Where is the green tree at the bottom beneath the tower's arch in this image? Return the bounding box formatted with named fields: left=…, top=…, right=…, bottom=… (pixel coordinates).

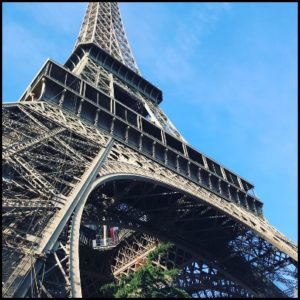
left=101, top=243, right=190, bottom=298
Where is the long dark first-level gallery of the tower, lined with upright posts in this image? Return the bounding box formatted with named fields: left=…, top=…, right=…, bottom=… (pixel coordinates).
left=18, top=58, right=262, bottom=215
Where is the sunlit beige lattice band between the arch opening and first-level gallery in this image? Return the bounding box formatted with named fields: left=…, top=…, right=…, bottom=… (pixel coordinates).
left=101, top=142, right=297, bottom=260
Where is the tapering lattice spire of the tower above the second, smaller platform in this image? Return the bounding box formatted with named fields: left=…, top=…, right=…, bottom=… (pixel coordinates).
left=75, top=2, right=140, bottom=74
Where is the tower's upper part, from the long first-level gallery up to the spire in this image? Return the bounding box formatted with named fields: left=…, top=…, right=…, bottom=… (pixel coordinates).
left=20, top=2, right=263, bottom=216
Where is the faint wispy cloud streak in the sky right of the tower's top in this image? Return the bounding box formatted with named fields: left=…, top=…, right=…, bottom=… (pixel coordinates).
left=155, top=3, right=231, bottom=83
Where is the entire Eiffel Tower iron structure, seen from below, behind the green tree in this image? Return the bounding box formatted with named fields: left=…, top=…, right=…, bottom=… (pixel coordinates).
left=2, top=2, right=298, bottom=298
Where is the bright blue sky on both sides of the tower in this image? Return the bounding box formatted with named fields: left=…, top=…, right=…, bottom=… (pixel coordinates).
left=3, top=3, right=298, bottom=242
